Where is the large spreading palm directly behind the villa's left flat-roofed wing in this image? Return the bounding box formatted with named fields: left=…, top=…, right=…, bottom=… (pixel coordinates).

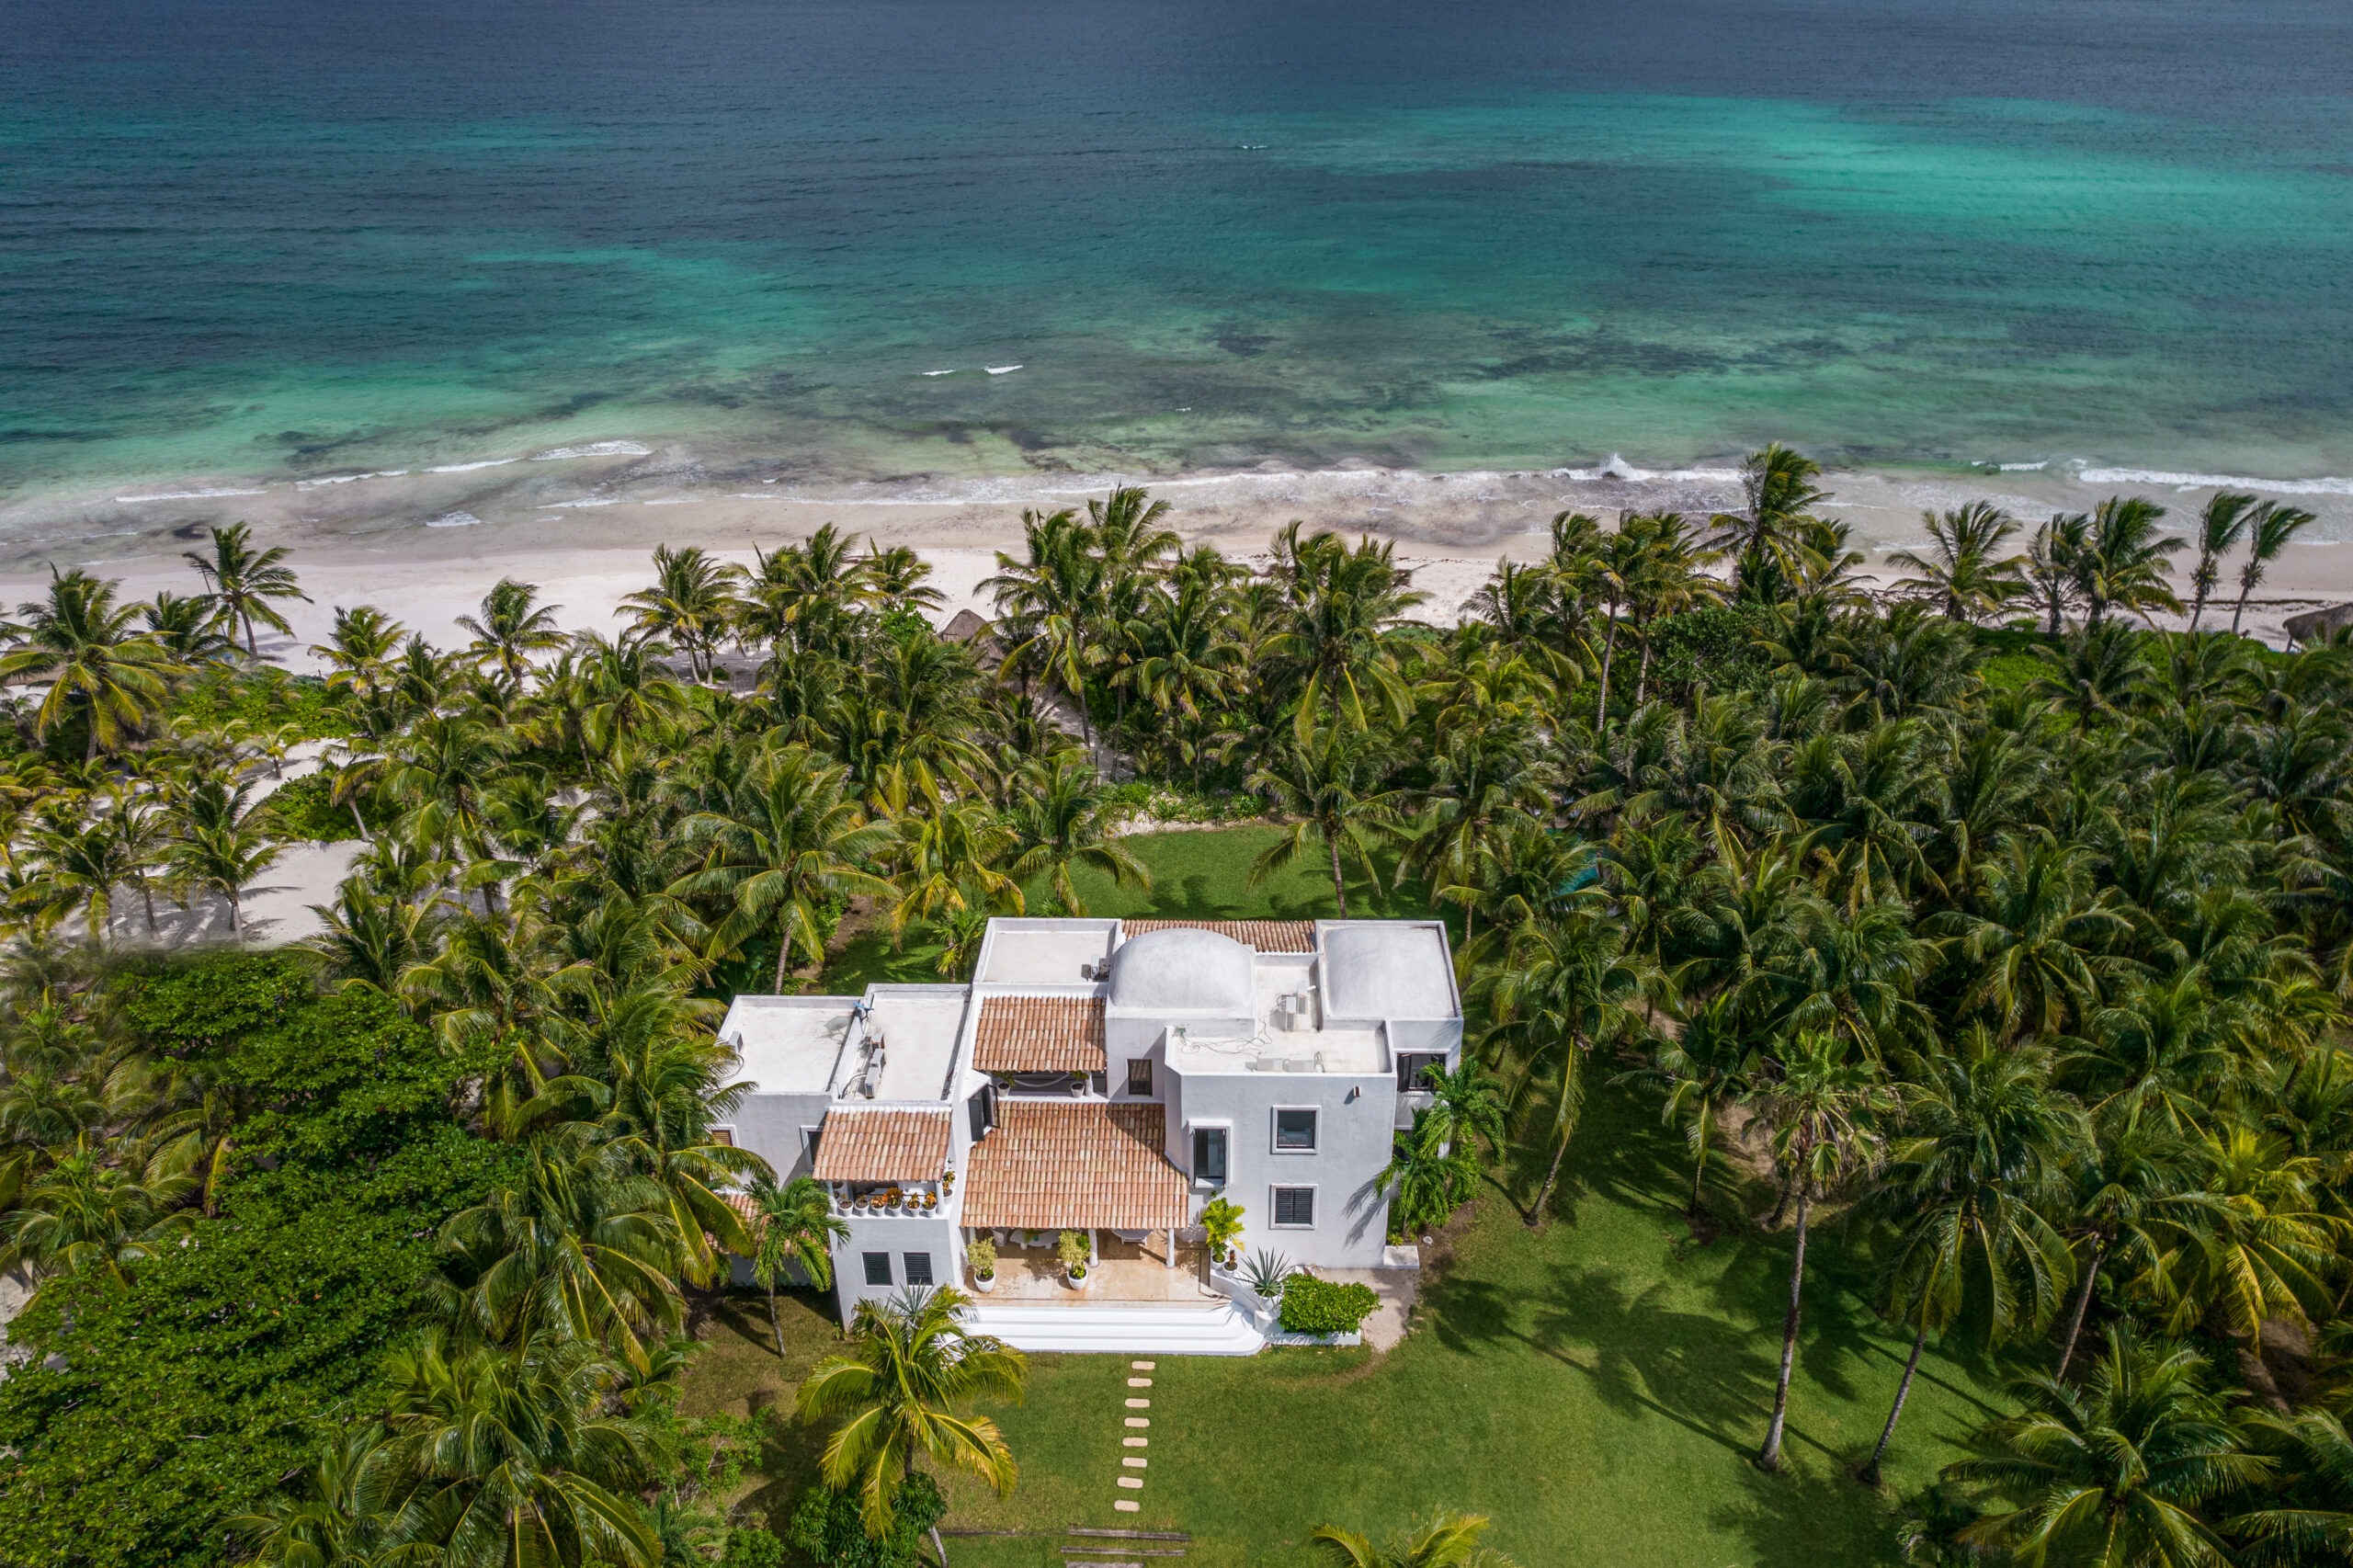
left=673, top=746, right=892, bottom=996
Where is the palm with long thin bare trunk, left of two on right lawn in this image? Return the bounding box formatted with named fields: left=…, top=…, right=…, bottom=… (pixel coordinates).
left=1757, top=1031, right=1894, bottom=1471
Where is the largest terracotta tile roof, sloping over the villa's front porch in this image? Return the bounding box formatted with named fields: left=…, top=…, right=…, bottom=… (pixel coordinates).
left=965, top=1099, right=1193, bottom=1232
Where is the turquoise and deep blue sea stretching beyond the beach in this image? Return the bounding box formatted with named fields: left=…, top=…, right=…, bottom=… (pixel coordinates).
left=0, top=0, right=2353, bottom=499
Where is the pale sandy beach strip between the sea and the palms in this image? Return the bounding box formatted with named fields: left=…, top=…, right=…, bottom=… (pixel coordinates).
left=0, top=443, right=2353, bottom=668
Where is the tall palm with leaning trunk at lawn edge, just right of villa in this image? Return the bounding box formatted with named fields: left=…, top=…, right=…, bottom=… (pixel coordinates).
left=1475, top=900, right=1661, bottom=1224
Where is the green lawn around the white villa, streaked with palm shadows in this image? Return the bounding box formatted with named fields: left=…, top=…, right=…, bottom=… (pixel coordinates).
left=688, top=826, right=2000, bottom=1568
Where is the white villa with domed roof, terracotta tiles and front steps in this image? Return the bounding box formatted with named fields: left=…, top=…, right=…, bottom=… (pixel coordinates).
left=720, top=918, right=1463, bottom=1354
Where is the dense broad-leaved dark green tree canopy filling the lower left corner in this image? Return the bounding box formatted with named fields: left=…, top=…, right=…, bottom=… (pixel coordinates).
left=0, top=1123, right=513, bottom=1568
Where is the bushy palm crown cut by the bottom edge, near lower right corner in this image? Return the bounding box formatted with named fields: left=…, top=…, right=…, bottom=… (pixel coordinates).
left=1944, top=1325, right=2266, bottom=1568
